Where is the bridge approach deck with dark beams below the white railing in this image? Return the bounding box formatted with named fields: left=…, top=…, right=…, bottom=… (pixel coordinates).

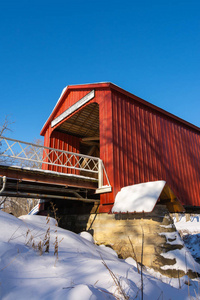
left=0, top=165, right=99, bottom=202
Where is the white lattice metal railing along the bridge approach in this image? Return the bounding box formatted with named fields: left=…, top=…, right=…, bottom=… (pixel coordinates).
left=0, top=136, right=110, bottom=188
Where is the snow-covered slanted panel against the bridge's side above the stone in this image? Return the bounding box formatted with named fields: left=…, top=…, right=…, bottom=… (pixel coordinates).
left=112, top=180, right=166, bottom=213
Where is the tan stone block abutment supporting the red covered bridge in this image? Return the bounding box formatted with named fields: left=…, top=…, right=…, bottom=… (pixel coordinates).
left=57, top=205, right=198, bottom=277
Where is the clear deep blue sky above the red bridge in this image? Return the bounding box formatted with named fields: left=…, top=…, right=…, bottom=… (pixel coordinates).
left=0, top=0, right=200, bottom=142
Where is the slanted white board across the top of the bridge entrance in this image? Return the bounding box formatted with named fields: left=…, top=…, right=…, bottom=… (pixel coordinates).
left=51, top=90, right=95, bottom=127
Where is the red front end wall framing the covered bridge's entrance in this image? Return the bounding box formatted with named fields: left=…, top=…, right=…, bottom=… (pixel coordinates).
left=43, top=89, right=114, bottom=209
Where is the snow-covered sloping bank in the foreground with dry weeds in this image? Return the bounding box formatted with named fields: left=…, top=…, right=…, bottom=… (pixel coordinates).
left=0, top=211, right=200, bottom=300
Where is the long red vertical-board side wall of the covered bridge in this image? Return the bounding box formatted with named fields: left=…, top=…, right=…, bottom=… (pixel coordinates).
left=112, top=91, right=200, bottom=210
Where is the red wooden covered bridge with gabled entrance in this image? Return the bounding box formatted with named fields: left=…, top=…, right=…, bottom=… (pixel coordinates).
left=41, top=83, right=200, bottom=212
